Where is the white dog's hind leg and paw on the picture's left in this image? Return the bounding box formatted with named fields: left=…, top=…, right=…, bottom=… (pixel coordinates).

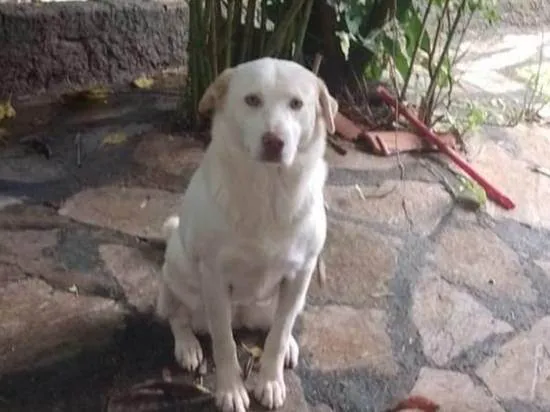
left=157, top=282, right=204, bottom=371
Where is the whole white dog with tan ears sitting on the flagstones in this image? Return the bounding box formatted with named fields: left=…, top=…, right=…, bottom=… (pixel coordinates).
left=157, top=58, right=338, bottom=412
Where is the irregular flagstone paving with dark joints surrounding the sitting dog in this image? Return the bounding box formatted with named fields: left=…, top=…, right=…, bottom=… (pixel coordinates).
left=0, top=84, right=550, bottom=412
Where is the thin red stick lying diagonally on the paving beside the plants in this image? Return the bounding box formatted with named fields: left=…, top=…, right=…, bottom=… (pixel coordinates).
left=376, top=86, right=516, bottom=210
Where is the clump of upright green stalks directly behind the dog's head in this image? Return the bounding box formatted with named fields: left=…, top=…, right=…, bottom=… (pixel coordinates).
left=187, top=0, right=315, bottom=127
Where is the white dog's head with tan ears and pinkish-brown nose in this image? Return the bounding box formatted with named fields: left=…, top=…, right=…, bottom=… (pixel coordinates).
left=199, top=58, right=338, bottom=166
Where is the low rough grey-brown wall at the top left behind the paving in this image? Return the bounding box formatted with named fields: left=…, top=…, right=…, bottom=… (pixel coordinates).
left=0, top=1, right=189, bottom=99
